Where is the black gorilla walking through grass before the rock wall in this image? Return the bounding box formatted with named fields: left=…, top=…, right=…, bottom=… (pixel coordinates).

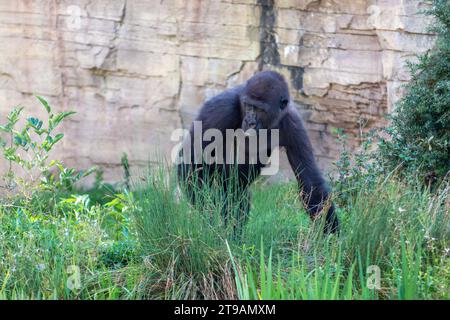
left=178, top=71, right=338, bottom=233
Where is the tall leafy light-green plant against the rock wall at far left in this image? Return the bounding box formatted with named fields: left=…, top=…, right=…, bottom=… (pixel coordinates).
left=0, top=96, right=93, bottom=196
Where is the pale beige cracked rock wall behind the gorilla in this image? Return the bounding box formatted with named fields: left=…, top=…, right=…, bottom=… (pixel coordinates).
left=0, top=0, right=434, bottom=180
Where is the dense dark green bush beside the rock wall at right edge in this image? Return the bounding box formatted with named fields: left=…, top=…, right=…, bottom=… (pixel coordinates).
left=379, top=0, right=450, bottom=184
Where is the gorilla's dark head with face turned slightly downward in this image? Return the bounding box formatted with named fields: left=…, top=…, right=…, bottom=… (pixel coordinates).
left=241, top=71, right=289, bottom=131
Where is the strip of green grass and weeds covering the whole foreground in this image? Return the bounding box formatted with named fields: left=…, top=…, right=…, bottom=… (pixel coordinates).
left=0, top=166, right=450, bottom=299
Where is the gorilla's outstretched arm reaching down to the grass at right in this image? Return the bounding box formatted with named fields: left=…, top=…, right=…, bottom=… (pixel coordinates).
left=280, top=106, right=338, bottom=232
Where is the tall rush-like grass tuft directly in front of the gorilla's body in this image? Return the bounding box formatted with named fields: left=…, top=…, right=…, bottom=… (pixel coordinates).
left=133, top=167, right=243, bottom=299
